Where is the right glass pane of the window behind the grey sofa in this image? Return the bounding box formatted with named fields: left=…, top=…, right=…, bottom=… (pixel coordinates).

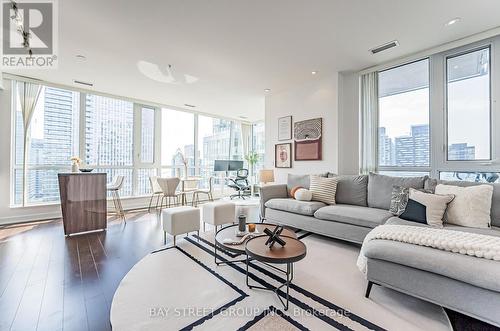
left=446, top=47, right=491, bottom=161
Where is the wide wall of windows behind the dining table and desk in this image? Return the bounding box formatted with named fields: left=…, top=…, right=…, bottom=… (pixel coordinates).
left=11, top=82, right=262, bottom=205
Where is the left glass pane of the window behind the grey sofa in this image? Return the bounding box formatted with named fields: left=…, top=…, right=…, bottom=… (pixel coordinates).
left=378, top=59, right=430, bottom=167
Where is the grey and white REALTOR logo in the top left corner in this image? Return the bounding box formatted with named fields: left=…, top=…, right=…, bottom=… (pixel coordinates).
left=1, top=0, right=57, bottom=69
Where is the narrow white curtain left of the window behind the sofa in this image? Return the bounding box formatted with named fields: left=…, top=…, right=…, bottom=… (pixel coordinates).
left=360, top=72, right=378, bottom=174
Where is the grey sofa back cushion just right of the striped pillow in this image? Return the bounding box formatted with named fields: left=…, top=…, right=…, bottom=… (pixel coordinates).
left=329, top=175, right=368, bottom=207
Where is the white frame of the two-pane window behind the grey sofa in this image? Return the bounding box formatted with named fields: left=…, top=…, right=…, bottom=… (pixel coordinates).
left=375, top=35, right=500, bottom=178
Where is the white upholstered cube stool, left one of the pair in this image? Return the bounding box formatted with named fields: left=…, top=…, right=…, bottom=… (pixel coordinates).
left=161, top=206, right=200, bottom=246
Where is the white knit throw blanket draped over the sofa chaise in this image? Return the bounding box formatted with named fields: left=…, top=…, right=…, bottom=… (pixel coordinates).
left=357, top=224, right=500, bottom=274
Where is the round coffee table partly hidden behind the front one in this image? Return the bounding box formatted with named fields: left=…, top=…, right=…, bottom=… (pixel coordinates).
left=214, top=223, right=297, bottom=265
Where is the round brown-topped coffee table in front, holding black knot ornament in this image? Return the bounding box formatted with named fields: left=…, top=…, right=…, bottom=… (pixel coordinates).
left=245, top=235, right=307, bottom=310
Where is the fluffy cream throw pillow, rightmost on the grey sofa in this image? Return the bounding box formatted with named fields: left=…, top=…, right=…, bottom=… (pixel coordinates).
left=435, top=184, right=493, bottom=228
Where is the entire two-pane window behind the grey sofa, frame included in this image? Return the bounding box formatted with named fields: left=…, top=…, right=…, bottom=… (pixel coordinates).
left=367, top=36, right=500, bottom=182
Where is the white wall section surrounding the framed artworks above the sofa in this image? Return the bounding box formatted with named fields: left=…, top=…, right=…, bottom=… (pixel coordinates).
left=265, top=73, right=340, bottom=183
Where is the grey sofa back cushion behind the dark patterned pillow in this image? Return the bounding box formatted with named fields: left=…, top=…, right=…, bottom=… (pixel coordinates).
left=368, top=172, right=428, bottom=210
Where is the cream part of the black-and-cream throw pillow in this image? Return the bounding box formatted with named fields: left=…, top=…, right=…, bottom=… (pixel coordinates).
left=408, top=188, right=455, bottom=228
